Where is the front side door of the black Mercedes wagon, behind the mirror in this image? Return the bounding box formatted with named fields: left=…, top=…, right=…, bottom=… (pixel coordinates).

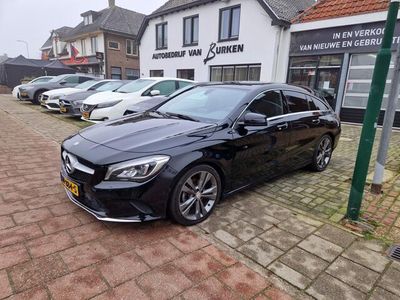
left=231, top=90, right=290, bottom=188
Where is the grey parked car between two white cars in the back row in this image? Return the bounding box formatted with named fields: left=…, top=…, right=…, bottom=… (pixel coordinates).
left=59, top=79, right=132, bottom=117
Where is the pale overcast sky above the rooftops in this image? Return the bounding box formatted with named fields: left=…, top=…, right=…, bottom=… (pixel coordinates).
left=0, top=0, right=166, bottom=58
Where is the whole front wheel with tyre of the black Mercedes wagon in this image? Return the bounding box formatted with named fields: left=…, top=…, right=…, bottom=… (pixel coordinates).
left=168, top=165, right=222, bottom=226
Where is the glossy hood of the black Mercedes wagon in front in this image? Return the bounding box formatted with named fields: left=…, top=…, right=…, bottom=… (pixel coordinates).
left=79, top=113, right=217, bottom=153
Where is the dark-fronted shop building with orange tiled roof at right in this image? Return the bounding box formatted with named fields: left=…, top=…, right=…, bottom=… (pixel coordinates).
left=287, top=0, right=400, bottom=127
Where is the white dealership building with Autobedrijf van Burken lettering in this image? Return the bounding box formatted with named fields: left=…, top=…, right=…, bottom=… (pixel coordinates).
left=138, top=0, right=315, bottom=82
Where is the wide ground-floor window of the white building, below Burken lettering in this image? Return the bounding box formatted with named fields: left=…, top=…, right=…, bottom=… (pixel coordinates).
left=210, top=64, right=261, bottom=81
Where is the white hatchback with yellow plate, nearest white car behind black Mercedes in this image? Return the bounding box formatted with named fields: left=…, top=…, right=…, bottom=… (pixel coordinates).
left=81, top=77, right=194, bottom=123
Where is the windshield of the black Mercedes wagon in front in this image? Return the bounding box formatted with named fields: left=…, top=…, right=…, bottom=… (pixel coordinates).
left=157, top=86, right=247, bottom=123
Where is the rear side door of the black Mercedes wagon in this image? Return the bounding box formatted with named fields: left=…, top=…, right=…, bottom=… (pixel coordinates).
left=283, top=91, right=321, bottom=169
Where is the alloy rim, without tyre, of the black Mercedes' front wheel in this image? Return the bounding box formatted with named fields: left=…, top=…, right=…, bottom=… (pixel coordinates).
left=179, top=171, right=219, bottom=221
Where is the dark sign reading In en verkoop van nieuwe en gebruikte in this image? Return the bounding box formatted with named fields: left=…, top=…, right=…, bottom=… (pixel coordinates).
left=290, top=22, right=400, bottom=56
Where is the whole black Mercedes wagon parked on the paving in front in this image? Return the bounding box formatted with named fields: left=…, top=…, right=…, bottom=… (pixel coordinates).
left=61, top=83, right=341, bottom=225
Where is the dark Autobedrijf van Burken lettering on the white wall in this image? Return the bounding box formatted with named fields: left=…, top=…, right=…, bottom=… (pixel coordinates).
left=153, top=42, right=244, bottom=64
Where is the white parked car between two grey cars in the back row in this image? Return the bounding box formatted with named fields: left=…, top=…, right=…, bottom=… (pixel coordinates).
left=39, top=79, right=112, bottom=111
